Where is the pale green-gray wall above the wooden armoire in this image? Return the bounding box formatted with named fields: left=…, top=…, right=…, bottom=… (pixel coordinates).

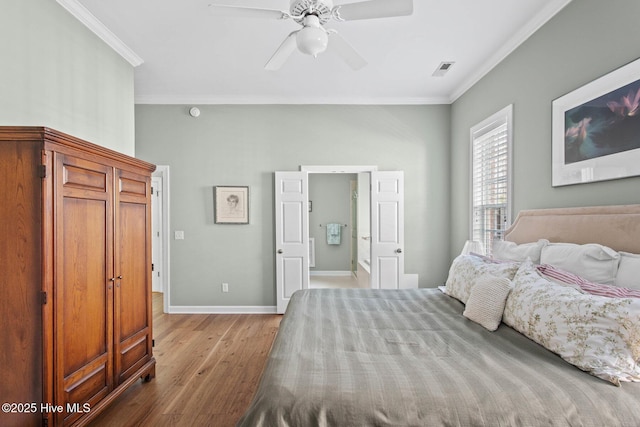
left=0, top=0, right=135, bottom=155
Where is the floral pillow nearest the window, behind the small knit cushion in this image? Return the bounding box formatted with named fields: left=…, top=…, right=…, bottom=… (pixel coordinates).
left=445, top=255, right=520, bottom=304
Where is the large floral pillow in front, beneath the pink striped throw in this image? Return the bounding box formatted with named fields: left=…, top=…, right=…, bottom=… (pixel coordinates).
left=503, top=261, right=640, bottom=386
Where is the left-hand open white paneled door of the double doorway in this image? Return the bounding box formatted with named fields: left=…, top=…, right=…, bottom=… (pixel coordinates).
left=275, top=172, right=309, bottom=313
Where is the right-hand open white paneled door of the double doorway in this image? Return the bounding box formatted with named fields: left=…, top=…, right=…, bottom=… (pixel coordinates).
left=371, top=171, right=404, bottom=289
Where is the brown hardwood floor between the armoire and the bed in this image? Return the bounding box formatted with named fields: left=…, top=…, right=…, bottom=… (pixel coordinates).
left=90, top=293, right=281, bottom=427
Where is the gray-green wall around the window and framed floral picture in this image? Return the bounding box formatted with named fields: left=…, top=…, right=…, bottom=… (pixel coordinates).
left=451, top=0, right=640, bottom=257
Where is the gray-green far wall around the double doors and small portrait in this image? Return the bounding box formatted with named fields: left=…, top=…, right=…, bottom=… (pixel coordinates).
left=136, top=105, right=450, bottom=306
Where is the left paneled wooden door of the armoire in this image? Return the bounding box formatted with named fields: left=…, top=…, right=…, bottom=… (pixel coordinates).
left=54, top=153, right=114, bottom=425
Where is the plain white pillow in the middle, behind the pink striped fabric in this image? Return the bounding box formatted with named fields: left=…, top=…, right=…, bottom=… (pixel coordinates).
left=540, top=243, right=620, bottom=285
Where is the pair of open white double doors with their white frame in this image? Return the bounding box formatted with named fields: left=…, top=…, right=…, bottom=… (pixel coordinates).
left=274, top=166, right=404, bottom=313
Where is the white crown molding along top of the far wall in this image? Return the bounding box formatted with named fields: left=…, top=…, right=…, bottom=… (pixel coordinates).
left=135, top=95, right=450, bottom=105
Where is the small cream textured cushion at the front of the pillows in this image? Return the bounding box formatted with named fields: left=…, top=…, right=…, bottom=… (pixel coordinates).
left=462, top=274, right=511, bottom=331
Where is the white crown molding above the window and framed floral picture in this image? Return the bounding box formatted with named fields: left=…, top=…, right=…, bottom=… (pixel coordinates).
left=448, top=0, right=571, bottom=104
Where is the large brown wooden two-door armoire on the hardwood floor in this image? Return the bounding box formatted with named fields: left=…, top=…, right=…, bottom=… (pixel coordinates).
left=0, top=127, right=155, bottom=427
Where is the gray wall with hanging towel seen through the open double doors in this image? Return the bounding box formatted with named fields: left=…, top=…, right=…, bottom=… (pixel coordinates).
left=309, top=173, right=358, bottom=271
